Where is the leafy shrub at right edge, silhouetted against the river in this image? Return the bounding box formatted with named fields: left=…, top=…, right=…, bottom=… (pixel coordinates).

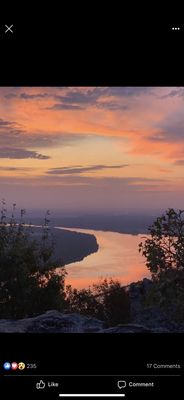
left=139, top=208, right=184, bottom=322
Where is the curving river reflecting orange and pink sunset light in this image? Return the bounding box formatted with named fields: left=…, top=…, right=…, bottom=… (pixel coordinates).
left=54, top=227, right=150, bottom=289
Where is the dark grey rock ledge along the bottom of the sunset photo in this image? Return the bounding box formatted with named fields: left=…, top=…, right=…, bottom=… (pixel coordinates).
left=0, top=310, right=184, bottom=334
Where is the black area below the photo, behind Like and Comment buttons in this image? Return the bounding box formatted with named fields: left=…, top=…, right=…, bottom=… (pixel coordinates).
left=0, top=333, right=184, bottom=399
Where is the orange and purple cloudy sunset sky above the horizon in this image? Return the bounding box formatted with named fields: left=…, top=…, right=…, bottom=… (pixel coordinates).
left=0, top=87, right=184, bottom=214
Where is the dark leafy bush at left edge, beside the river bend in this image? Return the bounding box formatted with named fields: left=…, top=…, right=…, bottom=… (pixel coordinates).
left=0, top=200, right=66, bottom=318
